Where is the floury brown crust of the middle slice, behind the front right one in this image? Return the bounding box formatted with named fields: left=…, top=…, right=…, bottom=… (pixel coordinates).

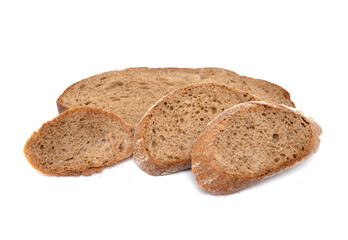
left=133, top=83, right=258, bottom=176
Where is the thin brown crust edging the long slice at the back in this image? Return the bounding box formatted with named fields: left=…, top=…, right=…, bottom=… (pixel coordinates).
left=56, top=67, right=295, bottom=126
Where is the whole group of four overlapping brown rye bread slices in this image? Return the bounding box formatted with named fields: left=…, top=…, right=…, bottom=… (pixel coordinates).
left=24, top=68, right=321, bottom=194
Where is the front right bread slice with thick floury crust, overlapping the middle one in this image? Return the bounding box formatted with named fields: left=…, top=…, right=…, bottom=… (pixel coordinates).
left=192, top=102, right=321, bottom=194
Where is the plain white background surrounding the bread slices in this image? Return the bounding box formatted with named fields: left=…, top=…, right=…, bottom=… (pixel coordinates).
left=0, top=0, right=348, bottom=239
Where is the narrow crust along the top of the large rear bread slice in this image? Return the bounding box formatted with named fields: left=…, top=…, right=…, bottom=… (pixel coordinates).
left=56, top=67, right=295, bottom=129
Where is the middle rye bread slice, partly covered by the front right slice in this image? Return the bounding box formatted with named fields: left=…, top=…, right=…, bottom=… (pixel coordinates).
left=133, top=83, right=258, bottom=175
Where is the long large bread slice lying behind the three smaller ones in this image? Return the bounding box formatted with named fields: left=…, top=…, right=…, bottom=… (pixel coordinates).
left=57, top=68, right=295, bottom=128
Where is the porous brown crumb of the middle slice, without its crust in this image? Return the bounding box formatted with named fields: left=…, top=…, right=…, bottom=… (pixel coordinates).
left=144, top=84, right=255, bottom=163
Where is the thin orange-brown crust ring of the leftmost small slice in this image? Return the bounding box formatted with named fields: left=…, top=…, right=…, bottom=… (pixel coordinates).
left=23, top=106, right=133, bottom=176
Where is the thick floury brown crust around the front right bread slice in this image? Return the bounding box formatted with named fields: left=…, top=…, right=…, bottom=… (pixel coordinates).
left=192, top=102, right=321, bottom=194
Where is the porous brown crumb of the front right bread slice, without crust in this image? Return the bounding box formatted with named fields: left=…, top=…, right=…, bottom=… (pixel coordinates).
left=214, top=105, right=313, bottom=177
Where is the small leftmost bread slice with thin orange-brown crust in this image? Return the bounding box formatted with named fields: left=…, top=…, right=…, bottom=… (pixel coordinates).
left=24, top=107, right=133, bottom=175
